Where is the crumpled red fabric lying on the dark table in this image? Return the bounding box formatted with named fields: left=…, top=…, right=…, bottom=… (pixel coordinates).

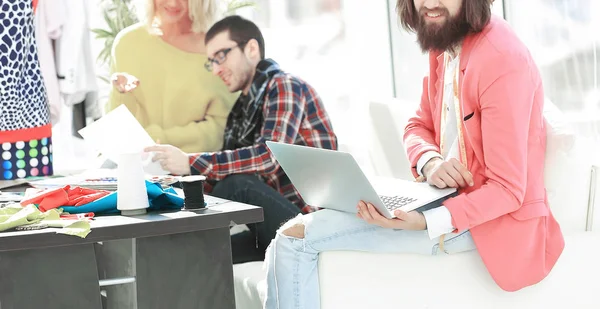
left=21, top=185, right=110, bottom=212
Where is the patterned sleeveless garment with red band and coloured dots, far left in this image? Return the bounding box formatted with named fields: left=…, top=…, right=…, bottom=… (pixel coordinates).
left=0, top=0, right=53, bottom=180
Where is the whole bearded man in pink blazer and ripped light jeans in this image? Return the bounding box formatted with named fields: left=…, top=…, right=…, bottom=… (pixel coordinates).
left=265, top=0, right=564, bottom=309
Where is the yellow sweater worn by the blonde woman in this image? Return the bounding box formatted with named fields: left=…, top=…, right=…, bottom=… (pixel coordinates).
left=108, top=24, right=239, bottom=153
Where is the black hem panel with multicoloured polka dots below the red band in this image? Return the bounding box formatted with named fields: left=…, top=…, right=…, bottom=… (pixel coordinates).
left=0, top=138, right=53, bottom=179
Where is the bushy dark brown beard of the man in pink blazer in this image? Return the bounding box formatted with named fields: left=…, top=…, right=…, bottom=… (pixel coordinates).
left=417, top=7, right=470, bottom=52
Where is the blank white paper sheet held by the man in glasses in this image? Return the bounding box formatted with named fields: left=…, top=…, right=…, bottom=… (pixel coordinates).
left=79, top=105, right=168, bottom=175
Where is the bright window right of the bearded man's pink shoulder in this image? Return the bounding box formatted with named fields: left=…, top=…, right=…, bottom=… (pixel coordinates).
left=504, top=0, right=600, bottom=140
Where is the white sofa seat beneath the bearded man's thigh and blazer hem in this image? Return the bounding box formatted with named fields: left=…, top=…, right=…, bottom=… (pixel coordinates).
left=319, top=232, right=600, bottom=309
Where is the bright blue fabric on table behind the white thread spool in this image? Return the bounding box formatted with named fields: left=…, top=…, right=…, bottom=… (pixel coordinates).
left=60, top=181, right=183, bottom=215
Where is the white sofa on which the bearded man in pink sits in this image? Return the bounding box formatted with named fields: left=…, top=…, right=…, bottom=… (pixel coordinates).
left=234, top=100, right=600, bottom=309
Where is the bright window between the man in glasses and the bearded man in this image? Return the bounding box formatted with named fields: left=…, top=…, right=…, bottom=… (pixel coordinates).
left=238, top=0, right=393, bottom=168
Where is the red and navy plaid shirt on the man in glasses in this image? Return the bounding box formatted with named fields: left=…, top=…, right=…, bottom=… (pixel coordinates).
left=189, top=59, right=337, bottom=213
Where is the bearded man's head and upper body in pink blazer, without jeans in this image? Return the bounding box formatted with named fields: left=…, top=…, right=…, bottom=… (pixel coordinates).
left=398, top=0, right=564, bottom=291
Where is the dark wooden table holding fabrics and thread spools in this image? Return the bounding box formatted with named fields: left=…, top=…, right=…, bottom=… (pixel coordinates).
left=0, top=197, right=263, bottom=309
